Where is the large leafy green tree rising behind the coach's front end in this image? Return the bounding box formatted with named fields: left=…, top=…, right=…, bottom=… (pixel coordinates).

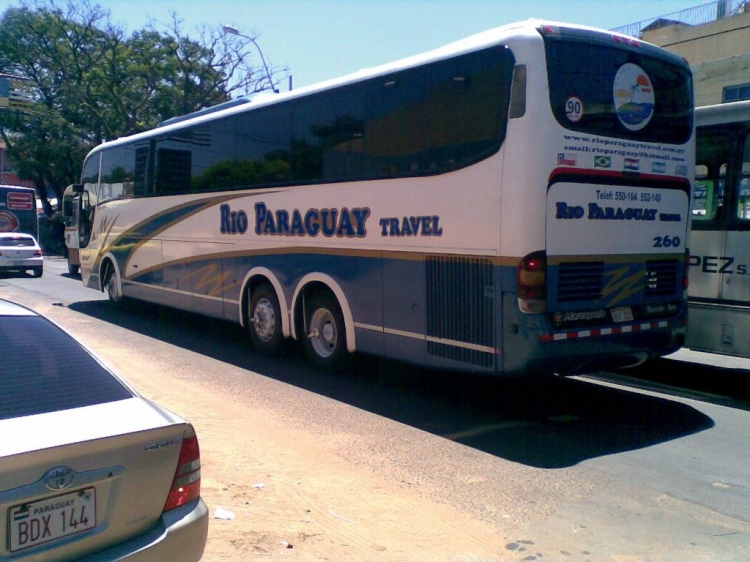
left=0, top=0, right=287, bottom=214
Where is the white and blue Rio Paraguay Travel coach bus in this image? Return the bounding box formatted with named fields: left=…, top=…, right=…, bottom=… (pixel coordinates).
left=67, top=21, right=695, bottom=376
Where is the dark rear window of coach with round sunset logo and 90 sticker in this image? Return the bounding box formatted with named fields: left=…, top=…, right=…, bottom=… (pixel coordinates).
left=544, top=34, right=693, bottom=144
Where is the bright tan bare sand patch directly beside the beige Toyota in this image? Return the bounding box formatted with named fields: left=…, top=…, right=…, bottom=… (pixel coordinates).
left=108, top=348, right=520, bottom=562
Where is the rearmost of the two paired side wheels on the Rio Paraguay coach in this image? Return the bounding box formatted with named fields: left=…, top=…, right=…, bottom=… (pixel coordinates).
left=303, top=292, right=348, bottom=373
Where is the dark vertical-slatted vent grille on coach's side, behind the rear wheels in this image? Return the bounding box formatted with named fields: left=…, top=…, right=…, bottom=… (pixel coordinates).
left=425, top=256, right=495, bottom=367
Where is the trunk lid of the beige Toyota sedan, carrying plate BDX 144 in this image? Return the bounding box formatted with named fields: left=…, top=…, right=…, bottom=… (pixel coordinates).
left=0, top=397, right=191, bottom=560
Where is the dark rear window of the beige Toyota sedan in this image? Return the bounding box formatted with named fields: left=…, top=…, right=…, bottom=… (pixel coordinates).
left=0, top=316, right=133, bottom=419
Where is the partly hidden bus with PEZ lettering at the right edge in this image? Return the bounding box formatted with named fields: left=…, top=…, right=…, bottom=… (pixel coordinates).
left=686, top=101, right=750, bottom=357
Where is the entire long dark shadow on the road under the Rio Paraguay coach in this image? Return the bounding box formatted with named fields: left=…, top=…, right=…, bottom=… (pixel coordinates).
left=69, top=301, right=714, bottom=469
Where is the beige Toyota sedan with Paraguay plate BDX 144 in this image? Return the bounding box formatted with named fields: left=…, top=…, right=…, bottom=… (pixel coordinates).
left=0, top=299, right=208, bottom=562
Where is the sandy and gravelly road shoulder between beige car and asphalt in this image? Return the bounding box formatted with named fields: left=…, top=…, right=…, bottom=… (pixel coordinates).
left=82, top=326, right=748, bottom=562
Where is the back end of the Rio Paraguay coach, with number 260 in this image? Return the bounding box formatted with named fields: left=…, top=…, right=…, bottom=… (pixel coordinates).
left=503, top=26, right=693, bottom=374
